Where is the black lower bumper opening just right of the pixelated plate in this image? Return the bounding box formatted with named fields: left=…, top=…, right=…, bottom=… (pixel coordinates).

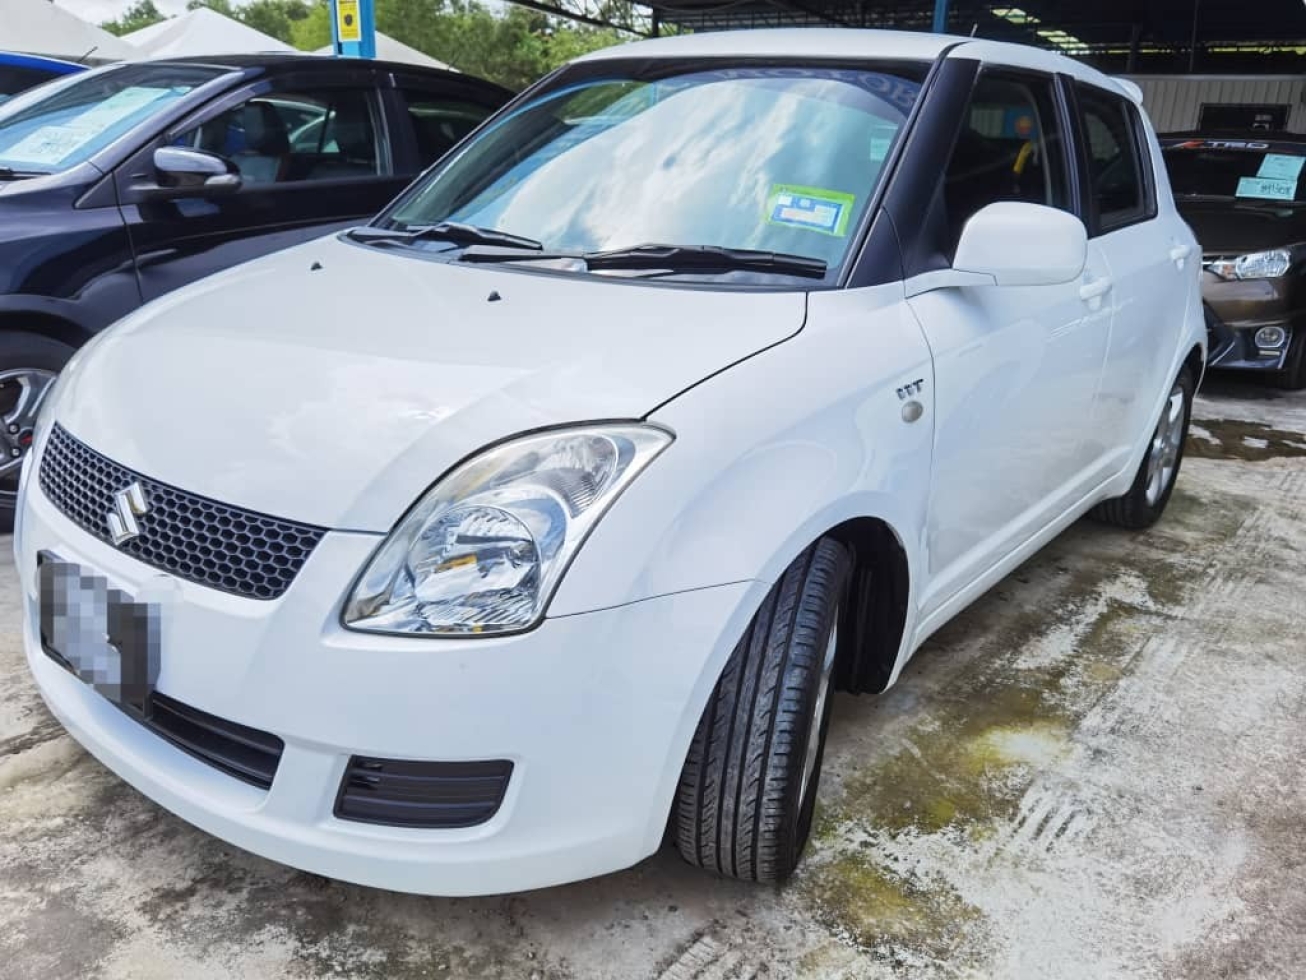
left=145, top=691, right=286, bottom=789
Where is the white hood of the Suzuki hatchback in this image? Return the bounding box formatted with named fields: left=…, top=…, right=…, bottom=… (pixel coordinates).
left=47, top=238, right=806, bottom=532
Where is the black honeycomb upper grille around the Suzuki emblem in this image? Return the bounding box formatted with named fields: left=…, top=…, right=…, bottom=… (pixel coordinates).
left=39, top=425, right=327, bottom=598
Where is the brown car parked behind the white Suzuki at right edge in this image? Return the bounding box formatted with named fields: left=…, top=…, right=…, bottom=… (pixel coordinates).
left=1161, top=132, right=1306, bottom=388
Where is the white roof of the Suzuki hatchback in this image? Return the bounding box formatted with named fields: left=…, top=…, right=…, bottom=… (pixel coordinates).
left=576, top=27, right=1140, bottom=102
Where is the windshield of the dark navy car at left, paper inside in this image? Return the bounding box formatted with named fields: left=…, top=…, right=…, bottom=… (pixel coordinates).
left=0, top=64, right=222, bottom=174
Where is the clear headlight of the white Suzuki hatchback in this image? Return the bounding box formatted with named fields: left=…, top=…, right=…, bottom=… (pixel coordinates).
left=343, top=425, right=671, bottom=636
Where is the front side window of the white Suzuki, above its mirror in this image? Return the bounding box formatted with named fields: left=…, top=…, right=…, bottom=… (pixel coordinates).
left=943, top=73, right=1071, bottom=255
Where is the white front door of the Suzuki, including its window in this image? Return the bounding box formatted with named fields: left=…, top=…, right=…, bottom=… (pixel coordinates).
left=910, top=72, right=1111, bottom=617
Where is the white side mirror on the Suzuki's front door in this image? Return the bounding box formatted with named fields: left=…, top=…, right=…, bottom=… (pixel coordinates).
left=952, top=201, right=1088, bottom=286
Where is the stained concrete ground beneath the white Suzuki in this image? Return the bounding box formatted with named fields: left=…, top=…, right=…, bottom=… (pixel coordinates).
left=0, top=385, right=1306, bottom=980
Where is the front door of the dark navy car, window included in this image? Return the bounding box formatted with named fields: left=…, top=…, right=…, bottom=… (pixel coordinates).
left=116, top=68, right=407, bottom=301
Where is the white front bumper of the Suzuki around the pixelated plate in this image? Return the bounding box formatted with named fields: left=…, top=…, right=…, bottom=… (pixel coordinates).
left=16, top=475, right=765, bottom=895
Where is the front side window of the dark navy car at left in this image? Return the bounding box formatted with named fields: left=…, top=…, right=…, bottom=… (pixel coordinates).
left=174, top=89, right=381, bottom=186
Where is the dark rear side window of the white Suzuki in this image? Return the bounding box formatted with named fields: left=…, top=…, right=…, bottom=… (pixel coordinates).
left=1076, top=85, right=1156, bottom=234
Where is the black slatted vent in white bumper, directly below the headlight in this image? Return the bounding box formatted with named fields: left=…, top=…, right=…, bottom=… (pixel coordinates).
left=336, top=755, right=512, bottom=828
